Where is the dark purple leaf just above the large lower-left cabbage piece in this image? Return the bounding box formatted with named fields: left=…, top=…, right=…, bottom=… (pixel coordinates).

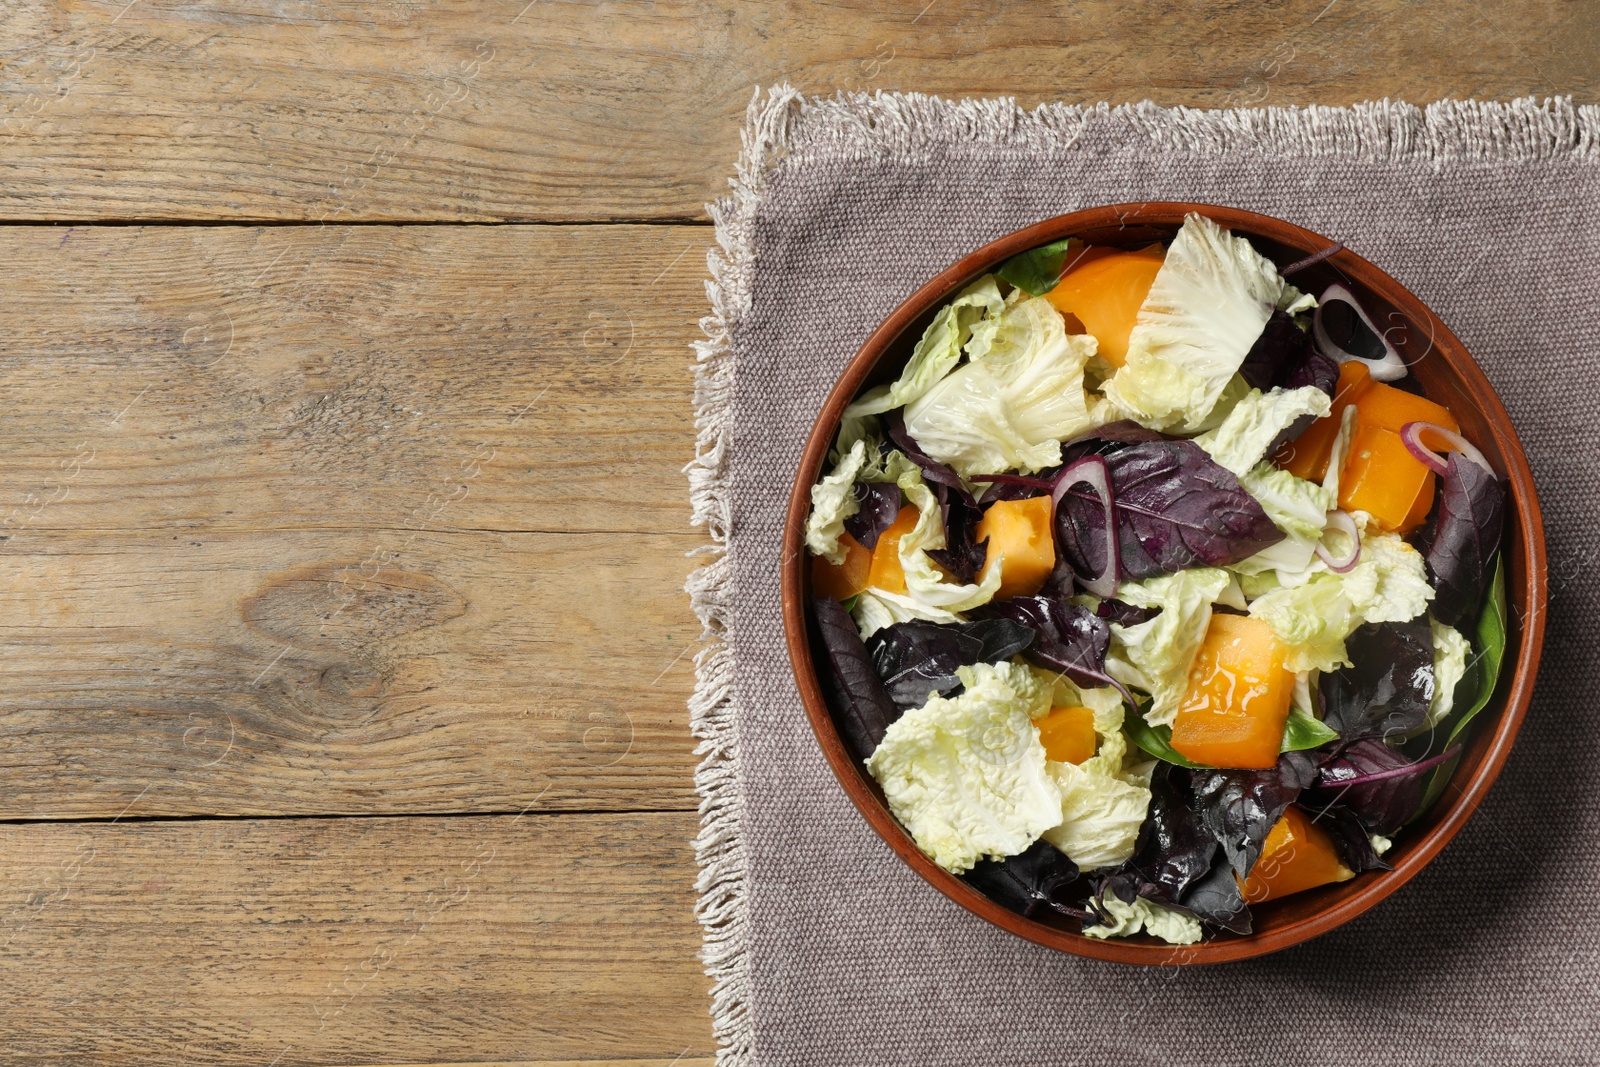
left=867, top=619, right=1034, bottom=707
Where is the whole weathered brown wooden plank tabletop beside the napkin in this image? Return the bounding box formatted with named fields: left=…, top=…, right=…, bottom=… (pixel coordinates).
left=0, top=0, right=1600, bottom=1067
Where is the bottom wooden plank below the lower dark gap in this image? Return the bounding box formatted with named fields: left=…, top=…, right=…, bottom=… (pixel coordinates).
left=0, top=813, right=712, bottom=1067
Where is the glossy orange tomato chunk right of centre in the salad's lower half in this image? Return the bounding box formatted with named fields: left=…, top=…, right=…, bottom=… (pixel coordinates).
left=1173, top=613, right=1294, bottom=768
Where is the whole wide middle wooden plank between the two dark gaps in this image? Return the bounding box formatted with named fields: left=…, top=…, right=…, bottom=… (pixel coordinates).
left=0, top=226, right=707, bottom=819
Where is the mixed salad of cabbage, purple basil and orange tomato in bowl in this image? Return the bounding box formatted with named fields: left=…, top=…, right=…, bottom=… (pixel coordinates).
left=794, top=210, right=1538, bottom=953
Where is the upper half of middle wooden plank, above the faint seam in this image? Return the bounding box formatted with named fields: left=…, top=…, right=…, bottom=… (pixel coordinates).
left=0, top=226, right=710, bottom=541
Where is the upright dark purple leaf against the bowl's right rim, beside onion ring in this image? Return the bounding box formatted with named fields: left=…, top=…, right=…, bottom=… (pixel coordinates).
left=1416, top=453, right=1506, bottom=627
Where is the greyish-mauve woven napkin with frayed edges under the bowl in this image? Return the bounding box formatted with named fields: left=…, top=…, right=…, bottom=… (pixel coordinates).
left=690, top=88, right=1600, bottom=1067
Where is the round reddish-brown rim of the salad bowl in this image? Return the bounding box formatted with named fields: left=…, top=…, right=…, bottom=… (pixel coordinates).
left=781, top=202, right=1549, bottom=966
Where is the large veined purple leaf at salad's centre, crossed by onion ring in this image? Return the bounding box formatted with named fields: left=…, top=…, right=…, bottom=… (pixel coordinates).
left=1056, top=440, right=1283, bottom=579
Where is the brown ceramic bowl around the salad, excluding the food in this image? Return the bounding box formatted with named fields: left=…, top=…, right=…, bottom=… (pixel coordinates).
left=782, top=203, right=1546, bottom=965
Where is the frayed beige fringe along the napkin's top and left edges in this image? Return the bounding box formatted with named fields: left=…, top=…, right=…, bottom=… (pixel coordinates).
left=685, top=85, right=1600, bottom=1067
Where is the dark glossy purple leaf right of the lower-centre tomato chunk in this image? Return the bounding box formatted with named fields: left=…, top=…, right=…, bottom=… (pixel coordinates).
left=1317, top=619, right=1434, bottom=741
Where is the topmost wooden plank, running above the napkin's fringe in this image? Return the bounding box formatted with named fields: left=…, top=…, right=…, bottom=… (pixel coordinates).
left=0, top=0, right=1600, bottom=222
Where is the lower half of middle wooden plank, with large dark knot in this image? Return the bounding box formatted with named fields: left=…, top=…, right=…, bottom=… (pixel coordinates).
left=0, top=531, right=699, bottom=819
